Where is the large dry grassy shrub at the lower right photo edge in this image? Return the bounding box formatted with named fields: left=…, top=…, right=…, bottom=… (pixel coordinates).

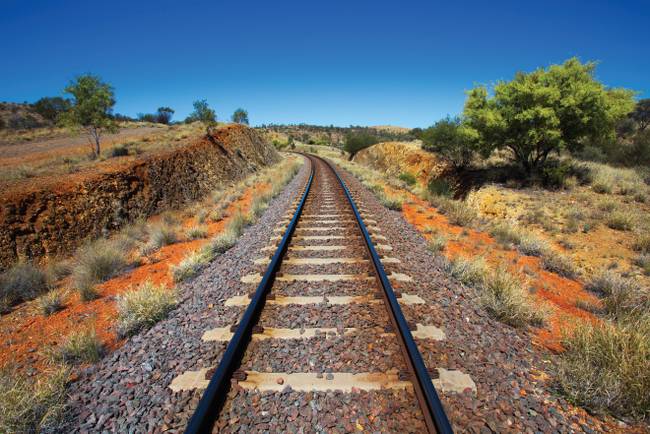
left=556, top=316, right=650, bottom=417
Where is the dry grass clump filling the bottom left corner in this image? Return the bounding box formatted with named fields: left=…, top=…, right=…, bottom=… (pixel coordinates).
left=0, top=368, right=69, bottom=433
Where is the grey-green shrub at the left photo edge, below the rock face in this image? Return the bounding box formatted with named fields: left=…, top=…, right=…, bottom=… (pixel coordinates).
left=0, top=263, right=48, bottom=312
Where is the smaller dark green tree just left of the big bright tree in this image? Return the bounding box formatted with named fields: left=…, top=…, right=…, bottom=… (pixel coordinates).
left=417, top=116, right=479, bottom=170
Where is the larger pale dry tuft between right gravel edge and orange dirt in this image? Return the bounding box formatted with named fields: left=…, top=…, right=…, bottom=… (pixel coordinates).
left=480, top=268, right=547, bottom=327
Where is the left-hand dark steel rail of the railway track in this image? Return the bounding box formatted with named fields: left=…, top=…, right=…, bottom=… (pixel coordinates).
left=185, top=159, right=315, bottom=434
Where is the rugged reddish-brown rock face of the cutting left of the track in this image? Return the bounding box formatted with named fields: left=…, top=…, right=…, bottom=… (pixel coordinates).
left=0, top=125, right=279, bottom=269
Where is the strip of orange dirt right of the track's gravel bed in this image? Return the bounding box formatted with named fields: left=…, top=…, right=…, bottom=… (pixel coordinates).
left=402, top=193, right=600, bottom=352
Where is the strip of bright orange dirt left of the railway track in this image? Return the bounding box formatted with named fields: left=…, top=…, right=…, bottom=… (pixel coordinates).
left=0, top=184, right=270, bottom=371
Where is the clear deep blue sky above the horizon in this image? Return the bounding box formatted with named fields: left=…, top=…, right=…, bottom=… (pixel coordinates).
left=0, top=0, right=650, bottom=127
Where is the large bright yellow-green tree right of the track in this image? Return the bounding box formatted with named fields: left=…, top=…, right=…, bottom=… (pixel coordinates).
left=463, top=58, right=634, bottom=174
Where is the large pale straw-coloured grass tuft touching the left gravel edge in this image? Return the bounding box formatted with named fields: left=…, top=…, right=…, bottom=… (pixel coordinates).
left=117, top=281, right=177, bottom=336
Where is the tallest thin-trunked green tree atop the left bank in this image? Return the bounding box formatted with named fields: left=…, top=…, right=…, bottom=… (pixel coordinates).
left=61, top=74, right=117, bottom=158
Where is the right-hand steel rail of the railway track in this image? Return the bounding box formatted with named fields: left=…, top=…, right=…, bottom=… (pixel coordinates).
left=316, top=157, right=453, bottom=434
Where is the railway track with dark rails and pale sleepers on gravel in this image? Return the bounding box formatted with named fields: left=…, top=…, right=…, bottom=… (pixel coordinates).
left=180, top=155, right=452, bottom=433
